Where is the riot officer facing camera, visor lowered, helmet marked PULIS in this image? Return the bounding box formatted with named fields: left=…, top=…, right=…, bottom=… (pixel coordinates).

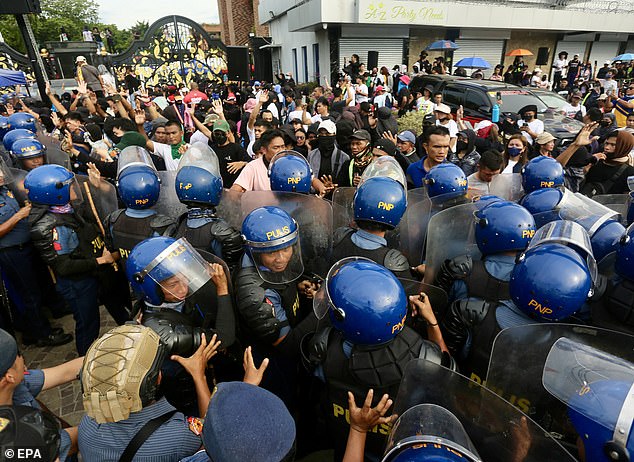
left=235, top=206, right=317, bottom=408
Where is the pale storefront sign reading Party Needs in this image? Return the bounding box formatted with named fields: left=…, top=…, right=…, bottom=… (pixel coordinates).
left=357, top=0, right=447, bottom=25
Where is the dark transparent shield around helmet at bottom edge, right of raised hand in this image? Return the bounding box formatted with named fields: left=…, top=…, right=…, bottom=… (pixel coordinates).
left=384, top=359, right=575, bottom=462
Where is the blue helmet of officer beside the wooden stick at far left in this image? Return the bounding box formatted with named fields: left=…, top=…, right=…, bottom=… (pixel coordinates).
left=24, top=165, right=76, bottom=205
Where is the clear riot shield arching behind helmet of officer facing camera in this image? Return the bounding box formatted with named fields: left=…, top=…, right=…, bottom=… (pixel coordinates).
left=241, top=191, right=333, bottom=276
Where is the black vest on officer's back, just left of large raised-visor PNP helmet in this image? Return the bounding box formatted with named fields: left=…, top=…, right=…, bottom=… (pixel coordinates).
left=461, top=260, right=511, bottom=379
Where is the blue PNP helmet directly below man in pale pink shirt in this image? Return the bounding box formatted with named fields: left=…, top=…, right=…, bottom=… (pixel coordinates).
left=269, top=151, right=313, bottom=194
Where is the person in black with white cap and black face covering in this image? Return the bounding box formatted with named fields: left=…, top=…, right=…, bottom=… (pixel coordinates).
left=308, top=120, right=348, bottom=195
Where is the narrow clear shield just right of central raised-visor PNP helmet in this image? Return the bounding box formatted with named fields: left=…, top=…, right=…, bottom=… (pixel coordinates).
left=398, top=189, right=432, bottom=266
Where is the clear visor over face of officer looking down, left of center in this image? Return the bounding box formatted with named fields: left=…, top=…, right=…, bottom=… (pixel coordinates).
left=137, top=238, right=213, bottom=302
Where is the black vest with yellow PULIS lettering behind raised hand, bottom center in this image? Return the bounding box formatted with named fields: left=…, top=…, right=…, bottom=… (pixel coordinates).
left=322, top=326, right=424, bottom=460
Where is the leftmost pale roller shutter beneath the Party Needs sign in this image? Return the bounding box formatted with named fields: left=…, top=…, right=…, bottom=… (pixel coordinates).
left=339, top=37, right=403, bottom=70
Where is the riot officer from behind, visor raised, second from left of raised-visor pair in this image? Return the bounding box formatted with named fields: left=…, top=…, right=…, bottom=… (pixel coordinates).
left=175, top=143, right=243, bottom=270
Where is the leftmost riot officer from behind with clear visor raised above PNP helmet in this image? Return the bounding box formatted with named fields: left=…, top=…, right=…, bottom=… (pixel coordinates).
left=105, top=146, right=176, bottom=263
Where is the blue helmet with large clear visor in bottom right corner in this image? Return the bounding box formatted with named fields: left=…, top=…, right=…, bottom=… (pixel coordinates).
left=542, top=337, right=634, bottom=462
